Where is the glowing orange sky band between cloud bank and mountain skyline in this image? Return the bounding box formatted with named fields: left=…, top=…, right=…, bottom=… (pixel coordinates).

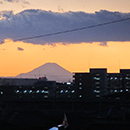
left=0, top=41, right=130, bottom=76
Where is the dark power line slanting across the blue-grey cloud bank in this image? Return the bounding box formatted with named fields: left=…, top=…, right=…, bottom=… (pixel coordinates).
left=0, top=17, right=130, bottom=43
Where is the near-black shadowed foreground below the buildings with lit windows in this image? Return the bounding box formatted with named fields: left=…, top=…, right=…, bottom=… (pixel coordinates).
left=0, top=101, right=130, bottom=130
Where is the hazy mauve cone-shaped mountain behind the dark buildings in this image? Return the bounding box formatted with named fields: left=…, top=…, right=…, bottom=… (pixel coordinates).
left=16, top=63, right=72, bottom=82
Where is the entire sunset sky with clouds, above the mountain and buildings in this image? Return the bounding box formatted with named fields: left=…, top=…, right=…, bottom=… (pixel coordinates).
left=0, top=0, right=130, bottom=77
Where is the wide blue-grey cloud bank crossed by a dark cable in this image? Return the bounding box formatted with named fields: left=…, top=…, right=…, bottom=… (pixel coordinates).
left=0, top=9, right=130, bottom=45
